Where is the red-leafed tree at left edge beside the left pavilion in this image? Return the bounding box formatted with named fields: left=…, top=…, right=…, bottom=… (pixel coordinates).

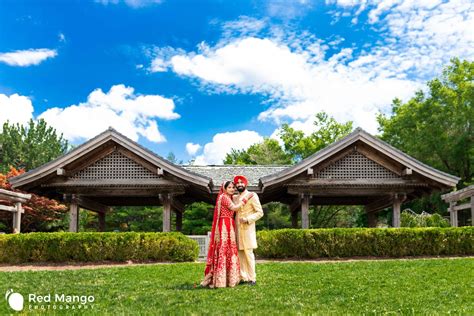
left=0, top=167, right=67, bottom=232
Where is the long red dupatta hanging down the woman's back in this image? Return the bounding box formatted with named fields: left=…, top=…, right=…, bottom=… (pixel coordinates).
left=201, top=184, right=225, bottom=286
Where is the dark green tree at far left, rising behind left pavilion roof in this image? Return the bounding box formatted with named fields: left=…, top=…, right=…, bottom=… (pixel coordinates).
left=0, top=119, right=68, bottom=173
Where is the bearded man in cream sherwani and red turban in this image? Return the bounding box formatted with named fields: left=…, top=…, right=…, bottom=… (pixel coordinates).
left=234, top=175, right=263, bottom=285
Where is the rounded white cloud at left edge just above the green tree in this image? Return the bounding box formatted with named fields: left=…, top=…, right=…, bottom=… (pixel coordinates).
left=0, top=94, right=33, bottom=131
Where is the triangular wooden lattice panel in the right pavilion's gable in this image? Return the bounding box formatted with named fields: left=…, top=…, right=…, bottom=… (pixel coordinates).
left=316, top=152, right=398, bottom=179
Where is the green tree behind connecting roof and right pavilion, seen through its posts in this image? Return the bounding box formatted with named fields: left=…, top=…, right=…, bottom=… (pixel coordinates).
left=224, top=112, right=363, bottom=229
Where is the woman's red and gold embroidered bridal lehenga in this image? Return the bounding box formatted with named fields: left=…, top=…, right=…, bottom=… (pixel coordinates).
left=201, top=187, right=240, bottom=288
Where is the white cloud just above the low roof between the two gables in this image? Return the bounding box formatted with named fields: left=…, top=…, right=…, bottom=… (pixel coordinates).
left=194, top=130, right=263, bottom=165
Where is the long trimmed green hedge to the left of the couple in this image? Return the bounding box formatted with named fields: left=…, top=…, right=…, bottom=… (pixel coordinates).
left=0, top=232, right=199, bottom=263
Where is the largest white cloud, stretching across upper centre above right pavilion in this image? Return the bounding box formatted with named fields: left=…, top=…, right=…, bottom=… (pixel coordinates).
left=163, top=37, right=420, bottom=132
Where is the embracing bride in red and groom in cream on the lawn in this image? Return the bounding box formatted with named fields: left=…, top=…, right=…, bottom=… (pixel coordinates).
left=201, top=176, right=263, bottom=288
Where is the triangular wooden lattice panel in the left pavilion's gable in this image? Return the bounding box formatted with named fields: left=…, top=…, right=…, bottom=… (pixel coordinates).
left=73, top=151, right=159, bottom=180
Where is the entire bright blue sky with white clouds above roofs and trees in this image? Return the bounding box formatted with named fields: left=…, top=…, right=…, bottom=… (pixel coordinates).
left=0, top=0, right=474, bottom=164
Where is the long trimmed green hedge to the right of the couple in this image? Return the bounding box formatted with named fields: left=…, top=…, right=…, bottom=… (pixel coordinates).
left=256, top=227, right=474, bottom=259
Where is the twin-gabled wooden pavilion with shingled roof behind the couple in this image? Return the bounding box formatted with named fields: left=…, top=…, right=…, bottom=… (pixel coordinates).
left=10, top=128, right=459, bottom=232
